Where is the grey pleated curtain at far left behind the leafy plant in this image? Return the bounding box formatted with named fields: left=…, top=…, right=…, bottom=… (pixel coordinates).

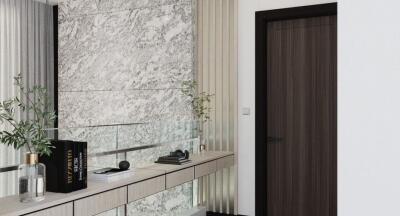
left=0, top=0, right=57, bottom=197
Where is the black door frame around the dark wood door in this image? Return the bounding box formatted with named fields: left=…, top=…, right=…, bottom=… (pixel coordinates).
left=255, top=3, right=337, bottom=216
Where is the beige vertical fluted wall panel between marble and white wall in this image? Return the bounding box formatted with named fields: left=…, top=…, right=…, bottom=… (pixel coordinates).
left=197, top=0, right=237, bottom=213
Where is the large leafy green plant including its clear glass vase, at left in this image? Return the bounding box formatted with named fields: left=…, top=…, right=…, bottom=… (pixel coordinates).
left=0, top=75, right=56, bottom=202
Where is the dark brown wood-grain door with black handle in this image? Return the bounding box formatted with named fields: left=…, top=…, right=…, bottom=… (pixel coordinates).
left=266, top=16, right=337, bottom=216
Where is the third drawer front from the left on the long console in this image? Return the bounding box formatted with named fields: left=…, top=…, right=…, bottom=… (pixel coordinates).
left=128, top=175, right=165, bottom=202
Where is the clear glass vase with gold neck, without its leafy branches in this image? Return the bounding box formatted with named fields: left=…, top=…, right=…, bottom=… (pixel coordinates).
left=18, top=153, right=46, bottom=202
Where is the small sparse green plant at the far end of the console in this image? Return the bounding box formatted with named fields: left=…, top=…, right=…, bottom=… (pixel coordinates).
left=182, top=80, right=214, bottom=152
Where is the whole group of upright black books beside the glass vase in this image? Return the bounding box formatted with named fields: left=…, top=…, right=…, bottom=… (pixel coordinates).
left=39, top=140, right=87, bottom=193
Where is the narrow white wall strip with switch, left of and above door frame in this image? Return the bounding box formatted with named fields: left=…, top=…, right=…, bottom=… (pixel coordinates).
left=238, top=0, right=336, bottom=215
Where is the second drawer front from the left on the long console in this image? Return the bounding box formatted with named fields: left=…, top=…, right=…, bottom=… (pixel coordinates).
left=74, top=187, right=127, bottom=216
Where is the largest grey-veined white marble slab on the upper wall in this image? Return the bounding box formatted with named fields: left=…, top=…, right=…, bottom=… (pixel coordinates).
left=59, top=5, right=194, bottom=91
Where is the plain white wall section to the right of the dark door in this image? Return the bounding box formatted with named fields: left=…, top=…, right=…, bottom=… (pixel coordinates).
left=338, top=0, right=400, bottom=216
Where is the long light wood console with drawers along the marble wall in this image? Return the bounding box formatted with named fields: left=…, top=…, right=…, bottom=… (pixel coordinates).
left=0, top=151, right=234, bottom=216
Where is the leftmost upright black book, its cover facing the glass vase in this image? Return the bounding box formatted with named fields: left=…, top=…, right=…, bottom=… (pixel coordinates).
left=39, top=140, right=74, bottom=193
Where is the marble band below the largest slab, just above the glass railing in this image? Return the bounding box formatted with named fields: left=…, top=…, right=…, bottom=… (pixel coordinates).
left=59, top=89, right=191, bottom=128
